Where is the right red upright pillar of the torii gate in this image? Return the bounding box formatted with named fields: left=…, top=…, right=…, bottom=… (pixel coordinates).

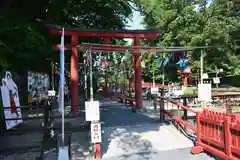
left=134, top=37, right=142, bottom=109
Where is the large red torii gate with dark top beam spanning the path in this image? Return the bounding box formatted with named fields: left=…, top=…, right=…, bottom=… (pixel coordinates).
left=47, top=25, right=201, bottom=112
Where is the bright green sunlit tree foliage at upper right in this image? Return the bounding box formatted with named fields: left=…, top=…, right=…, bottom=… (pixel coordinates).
left=135, top=0, right=240, bottom=82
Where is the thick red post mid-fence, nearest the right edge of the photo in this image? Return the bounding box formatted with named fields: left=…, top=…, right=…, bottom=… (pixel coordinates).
left=223, top=116, right=232, bottom=158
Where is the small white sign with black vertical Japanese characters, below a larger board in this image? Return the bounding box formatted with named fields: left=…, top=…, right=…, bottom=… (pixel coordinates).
left=91, top=122, right=102, bottom=143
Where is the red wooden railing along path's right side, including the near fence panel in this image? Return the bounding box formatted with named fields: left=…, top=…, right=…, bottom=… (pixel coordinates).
left=119, top=95, right=240, bottom=160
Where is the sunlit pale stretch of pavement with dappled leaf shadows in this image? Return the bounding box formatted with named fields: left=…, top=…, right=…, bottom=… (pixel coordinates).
left=103, top=124, right=193, bottom=159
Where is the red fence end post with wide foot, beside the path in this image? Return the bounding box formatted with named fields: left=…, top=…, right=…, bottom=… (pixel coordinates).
left=191, top=112, right=203, bottom=154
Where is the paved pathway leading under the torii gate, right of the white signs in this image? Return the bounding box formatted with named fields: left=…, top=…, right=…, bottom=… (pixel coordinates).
left=101, top=101, right=212, bottom=160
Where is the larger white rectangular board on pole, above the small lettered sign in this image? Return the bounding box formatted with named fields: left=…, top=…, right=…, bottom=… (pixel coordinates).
left=85, top=101, right=100, bottom=121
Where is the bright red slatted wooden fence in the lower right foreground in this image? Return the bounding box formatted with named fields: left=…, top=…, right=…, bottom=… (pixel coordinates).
left=191, top=109, right=240, bottom=160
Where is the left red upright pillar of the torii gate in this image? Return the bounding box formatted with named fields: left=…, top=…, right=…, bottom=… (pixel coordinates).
left=71, top=36, right=78, bottom=112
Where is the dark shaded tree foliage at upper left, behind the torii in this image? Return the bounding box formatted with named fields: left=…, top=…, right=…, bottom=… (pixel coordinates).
left=0, top=0, right=132, bottom=71
